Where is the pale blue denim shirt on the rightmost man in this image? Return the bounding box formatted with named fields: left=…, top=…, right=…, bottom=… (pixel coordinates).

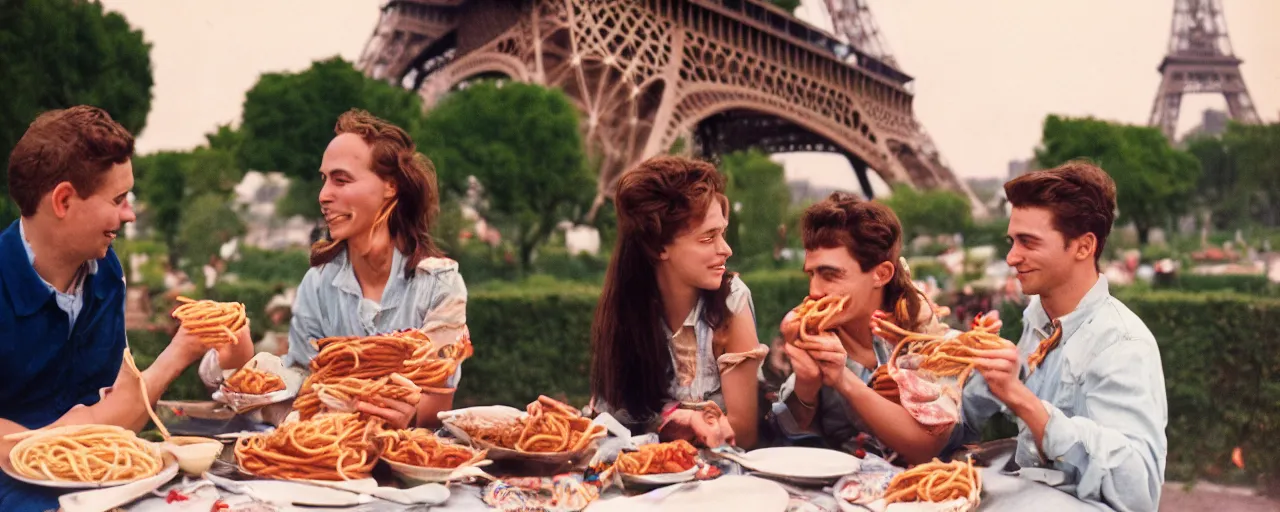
left=948, top=275, right=1169, bottom=511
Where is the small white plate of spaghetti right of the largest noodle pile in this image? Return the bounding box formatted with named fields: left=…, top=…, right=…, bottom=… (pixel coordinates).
left=378, top=429, right=492, bottom=481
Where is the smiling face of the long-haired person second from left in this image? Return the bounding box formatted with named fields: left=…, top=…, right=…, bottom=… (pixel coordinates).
left=320, top=133, right=396, bottom=241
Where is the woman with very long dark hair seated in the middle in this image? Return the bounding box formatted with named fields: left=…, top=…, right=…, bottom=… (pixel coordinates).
left=591, top=156, right=768, bottom=447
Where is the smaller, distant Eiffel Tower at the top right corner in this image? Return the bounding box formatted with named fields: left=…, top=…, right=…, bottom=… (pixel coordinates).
left=1148, top=0, right=1260, bottom=141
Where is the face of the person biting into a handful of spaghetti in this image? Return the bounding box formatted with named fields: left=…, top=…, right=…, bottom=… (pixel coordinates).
left=804, top=247, right=893, bottom=325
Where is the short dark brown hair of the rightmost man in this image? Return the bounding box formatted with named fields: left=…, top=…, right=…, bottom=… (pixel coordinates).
left=1005, top=161, right=1116, bottom=266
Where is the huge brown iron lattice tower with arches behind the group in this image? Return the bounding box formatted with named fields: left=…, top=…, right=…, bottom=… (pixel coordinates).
left=357, top=0, right=984, bottom=215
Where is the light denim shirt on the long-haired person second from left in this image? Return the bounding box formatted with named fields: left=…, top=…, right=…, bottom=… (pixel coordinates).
left=284, top=250, right=467, bottom=387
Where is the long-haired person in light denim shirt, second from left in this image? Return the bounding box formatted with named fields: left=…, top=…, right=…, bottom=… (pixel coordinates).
left=285, top=110, right=467, bottom=428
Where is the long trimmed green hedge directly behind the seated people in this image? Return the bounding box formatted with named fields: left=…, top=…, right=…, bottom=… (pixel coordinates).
left=129, top=271, right=1280, bottom=488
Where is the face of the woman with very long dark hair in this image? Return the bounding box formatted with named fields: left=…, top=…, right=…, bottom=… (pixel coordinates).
left=658, top=202, right=733, bottom=291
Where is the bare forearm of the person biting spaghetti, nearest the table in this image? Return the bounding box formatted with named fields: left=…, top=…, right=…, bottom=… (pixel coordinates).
left=837, top=372, right=951, bottom=463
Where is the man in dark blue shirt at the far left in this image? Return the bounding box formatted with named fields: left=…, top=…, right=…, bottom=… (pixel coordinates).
left=0, top=106, right=242, bottom=512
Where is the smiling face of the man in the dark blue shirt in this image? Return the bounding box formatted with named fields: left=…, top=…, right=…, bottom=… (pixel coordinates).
left=51, top=160, right=137, bottom=261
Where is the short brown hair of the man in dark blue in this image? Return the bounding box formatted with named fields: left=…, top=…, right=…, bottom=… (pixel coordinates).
left=9, top=105, right=133, bottom=216
